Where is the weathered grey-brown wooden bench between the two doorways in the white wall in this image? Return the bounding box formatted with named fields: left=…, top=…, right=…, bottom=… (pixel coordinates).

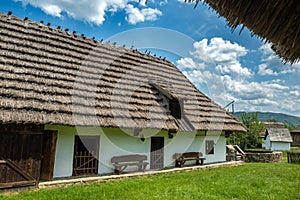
left=111, top=154, right=149, bottom=174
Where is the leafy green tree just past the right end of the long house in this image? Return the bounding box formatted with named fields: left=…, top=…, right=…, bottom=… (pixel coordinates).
left=227, top=113, right=265, bottom=150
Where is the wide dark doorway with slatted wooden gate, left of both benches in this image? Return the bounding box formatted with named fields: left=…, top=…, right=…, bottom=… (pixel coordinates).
left=73, top=135, right=99, bottom=176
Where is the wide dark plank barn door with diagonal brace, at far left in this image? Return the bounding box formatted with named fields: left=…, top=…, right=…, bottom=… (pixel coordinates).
left=0, top=132, right=43, bottom=186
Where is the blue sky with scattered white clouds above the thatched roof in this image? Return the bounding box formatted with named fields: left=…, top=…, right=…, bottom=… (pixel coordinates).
left=0, top=0, right=300, bottom=117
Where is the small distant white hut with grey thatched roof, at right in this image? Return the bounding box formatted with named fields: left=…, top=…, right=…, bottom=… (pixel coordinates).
left=264, top=122, right=293, bottom=151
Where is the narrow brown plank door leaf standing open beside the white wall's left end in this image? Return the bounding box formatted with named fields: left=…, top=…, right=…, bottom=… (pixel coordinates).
left=40, top=131, right=57, bottom=181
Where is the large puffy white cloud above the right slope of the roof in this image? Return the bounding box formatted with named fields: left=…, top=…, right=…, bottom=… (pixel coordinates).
left=191, top=38, right=252, bottom=76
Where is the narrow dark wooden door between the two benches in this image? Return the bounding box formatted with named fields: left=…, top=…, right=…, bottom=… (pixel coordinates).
left=150, top=137, right=164, bottom=169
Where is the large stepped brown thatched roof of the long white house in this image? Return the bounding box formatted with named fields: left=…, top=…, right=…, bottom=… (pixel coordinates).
left=0, top=14, right=246, bottom=131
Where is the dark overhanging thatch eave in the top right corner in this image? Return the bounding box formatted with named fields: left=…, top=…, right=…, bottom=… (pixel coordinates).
left=186, top=0, right=300, bottom=63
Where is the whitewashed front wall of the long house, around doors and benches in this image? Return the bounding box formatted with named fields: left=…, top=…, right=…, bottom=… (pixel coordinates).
left=45, top=125, right=226, bottom=177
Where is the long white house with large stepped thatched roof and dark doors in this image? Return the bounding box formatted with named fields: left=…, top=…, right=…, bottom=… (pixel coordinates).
left=0, top=14, right=246, bottom=188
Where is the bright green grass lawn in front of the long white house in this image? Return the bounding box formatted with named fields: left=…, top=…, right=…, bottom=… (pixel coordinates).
left=0, top=162, right=300, bottom=200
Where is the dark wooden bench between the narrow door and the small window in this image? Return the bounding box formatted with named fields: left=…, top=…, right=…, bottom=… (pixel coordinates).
left=174, top=152, right=205, bottom=167
